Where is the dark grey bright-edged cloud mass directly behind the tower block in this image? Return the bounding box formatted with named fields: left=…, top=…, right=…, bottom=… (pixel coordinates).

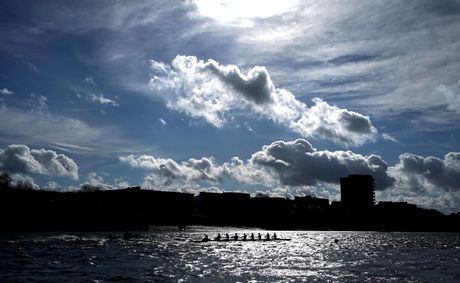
left=250, top=139, right=394, bottom=189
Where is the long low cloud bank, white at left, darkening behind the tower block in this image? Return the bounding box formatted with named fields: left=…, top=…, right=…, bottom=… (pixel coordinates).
left=120, top=139, right=394, bottom=189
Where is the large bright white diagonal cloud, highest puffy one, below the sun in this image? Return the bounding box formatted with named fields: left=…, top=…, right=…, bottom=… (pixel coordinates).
left=149, top=55, right=377, bottom=146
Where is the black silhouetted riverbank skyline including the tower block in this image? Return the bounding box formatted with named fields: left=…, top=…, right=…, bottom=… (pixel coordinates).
left=0, top=175, right=460, bottom=233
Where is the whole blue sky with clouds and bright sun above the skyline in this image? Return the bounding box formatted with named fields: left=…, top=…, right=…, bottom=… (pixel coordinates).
left=0, top=0, right=460, bottom=213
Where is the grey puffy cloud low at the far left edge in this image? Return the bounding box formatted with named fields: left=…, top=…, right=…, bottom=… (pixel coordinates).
left=0, top=144, right=78, bottom=180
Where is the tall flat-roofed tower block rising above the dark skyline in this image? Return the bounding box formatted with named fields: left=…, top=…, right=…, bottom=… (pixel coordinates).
left=340, top=175, right=375, bottom=208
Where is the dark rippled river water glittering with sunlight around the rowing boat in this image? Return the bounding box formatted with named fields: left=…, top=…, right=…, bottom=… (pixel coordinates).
left=0, top=227, right=460, bottom=282
